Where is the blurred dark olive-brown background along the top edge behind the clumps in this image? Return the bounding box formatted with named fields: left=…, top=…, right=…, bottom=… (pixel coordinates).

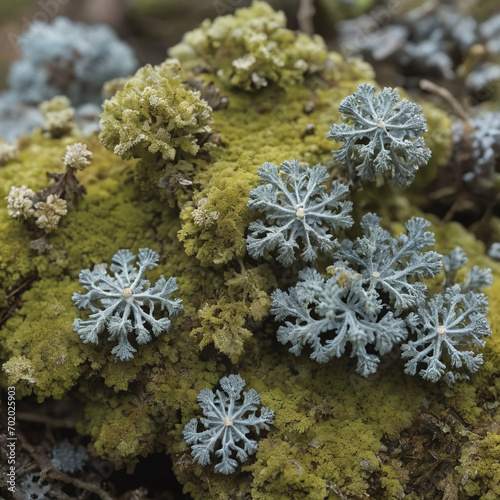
left=0, top=0, right=375, bottom=88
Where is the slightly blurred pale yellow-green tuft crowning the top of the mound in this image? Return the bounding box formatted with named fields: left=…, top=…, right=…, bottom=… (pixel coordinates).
left=170, top=1, right=328, bottom=91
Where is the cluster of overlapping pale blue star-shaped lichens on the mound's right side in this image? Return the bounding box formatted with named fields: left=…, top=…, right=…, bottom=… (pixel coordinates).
left=271, top=210, right=493, bottom=378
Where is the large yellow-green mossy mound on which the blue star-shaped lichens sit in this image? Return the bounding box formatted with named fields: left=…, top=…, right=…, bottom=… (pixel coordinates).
left=0, top=4, right=500, bottom=500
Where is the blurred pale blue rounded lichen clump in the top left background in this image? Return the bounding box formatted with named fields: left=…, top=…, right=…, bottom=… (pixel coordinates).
left=9, top=17, right=137, bottom=105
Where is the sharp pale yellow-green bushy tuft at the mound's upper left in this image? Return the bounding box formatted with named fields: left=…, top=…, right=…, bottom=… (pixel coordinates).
left=100, top=60, right=212, bottom=161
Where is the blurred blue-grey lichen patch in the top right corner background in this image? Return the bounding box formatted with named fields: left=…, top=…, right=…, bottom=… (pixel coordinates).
left=338, top=7, right=500, bottom=92
